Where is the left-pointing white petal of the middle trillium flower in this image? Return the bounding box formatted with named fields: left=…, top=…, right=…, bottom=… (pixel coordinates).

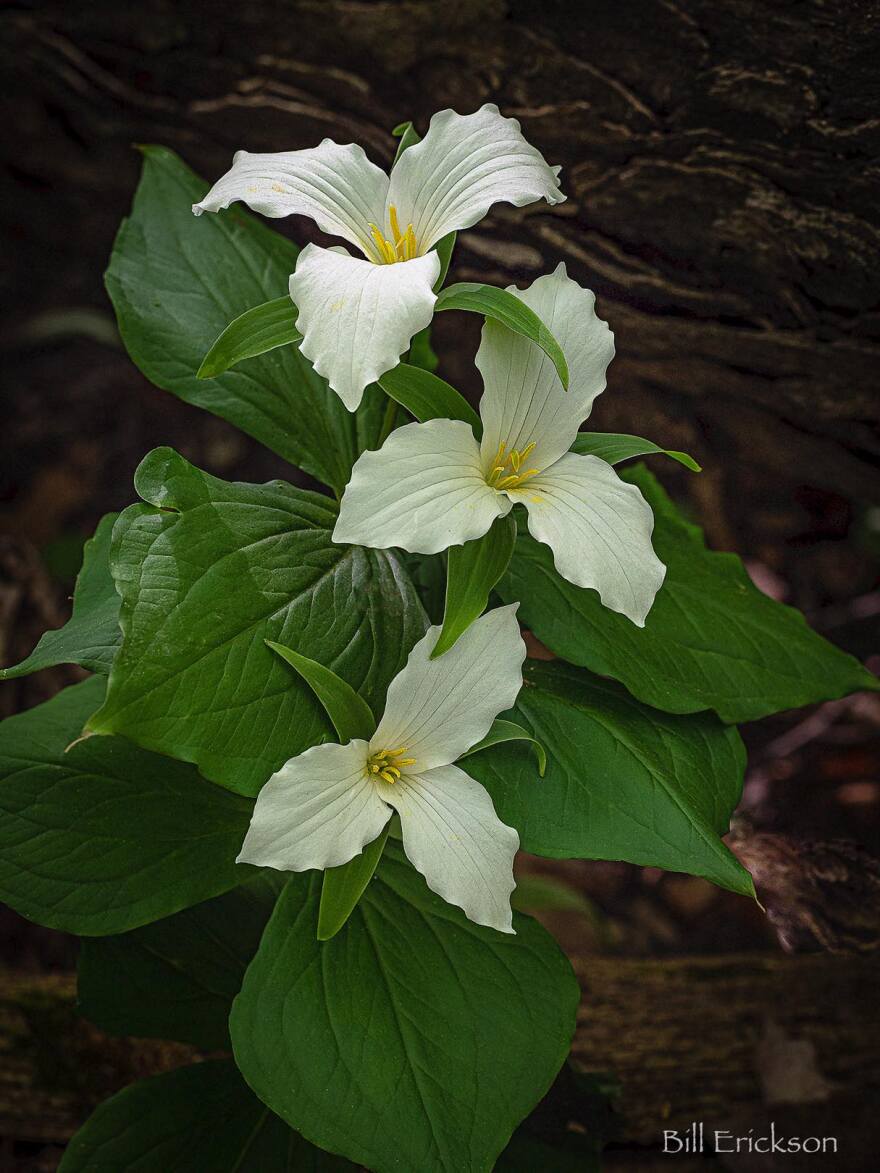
left=333, top=420, right=512, bottom=554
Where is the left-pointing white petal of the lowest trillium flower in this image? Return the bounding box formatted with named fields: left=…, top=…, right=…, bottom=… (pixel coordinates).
left=237, top=740, right=391, bottom=872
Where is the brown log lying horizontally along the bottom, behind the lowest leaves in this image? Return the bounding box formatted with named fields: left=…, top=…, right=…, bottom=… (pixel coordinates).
left=0, top=954, right=880, bottom=1173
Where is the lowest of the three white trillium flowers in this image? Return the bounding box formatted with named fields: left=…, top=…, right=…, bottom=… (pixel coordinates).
left=238, top=604, right=526, bottom=933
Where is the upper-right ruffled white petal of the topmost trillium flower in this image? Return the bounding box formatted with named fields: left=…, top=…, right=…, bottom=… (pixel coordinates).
left=388, top=106, right=566, bottom=252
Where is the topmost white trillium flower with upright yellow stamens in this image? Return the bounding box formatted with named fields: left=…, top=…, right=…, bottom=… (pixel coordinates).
left=192, top=106, right=566, bottom=412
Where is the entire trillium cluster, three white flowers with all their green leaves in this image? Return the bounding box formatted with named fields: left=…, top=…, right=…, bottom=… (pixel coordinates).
left=0, top=106, right=876, bottom=1173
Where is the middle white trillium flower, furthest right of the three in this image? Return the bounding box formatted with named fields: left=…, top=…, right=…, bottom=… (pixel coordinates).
left=333, top=265, right=665, bottom=628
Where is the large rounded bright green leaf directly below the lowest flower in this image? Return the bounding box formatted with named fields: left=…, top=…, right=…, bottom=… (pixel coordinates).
left=230, top=841, right=580, bottom=1173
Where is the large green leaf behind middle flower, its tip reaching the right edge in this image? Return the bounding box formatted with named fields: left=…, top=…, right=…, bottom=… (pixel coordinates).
left=497, top=467, right=880, bottom=721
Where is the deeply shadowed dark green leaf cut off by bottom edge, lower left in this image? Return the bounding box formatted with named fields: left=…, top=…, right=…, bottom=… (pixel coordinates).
left=59, top=1059, right=354, bottom=1173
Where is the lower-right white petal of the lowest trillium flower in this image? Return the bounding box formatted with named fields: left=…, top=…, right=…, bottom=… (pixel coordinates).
left=379, top=766, right=520, bottom=933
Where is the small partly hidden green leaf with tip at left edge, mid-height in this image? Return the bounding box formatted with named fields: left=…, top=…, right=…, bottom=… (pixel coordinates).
left=0, top=514, right=122, bottom=680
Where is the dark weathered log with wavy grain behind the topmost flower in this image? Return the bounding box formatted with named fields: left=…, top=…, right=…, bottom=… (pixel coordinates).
left=0, top=0, right=880, bottom=497
